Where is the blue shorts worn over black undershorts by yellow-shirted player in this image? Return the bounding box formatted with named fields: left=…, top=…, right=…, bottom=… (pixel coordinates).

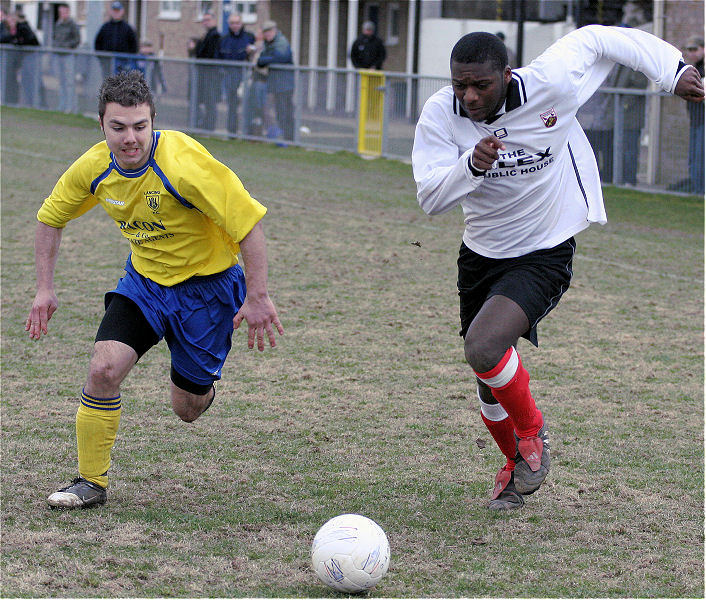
left=106, top=258, right=245, bottom=385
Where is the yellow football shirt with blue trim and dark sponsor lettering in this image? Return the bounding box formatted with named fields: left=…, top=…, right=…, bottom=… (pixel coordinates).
left=37, top=130, right=267, bottom=286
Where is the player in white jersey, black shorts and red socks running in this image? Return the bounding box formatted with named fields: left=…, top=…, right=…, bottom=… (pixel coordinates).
left=412, top=25, right=704, bottom=510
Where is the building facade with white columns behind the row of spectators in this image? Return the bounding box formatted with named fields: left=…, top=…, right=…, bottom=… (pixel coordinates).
left=8, top=0, right=704, bottom=75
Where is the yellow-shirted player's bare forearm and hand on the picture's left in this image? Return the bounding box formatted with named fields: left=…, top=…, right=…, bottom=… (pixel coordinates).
left=25, top=222, right=64, bottom=340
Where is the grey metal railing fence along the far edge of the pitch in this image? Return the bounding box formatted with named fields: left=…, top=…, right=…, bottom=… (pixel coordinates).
left=0, top=45, right=687, bottom=185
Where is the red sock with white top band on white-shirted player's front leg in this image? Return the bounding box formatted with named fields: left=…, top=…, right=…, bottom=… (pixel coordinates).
left=476, top=347, right=544, bottom=438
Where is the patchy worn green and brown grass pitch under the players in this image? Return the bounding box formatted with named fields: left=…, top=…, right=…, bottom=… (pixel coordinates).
left=0, top=108, right=704, bottom=598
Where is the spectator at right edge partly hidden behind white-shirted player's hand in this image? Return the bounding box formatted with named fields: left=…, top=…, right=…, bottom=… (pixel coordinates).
left=668, top=35, right=706, bottom=194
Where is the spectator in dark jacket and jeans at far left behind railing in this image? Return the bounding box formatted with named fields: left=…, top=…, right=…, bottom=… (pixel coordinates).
left=5, top=11, right=39, bottom=105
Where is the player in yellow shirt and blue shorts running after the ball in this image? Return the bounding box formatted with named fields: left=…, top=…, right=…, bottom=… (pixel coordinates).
left=25, top=71, right=284, bottom=508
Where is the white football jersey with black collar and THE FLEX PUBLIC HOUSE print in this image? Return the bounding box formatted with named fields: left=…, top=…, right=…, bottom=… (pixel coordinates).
left=412, top=25, right=687, bottom=258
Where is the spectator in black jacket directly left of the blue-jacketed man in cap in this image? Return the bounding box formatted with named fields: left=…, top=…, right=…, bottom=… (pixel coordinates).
left=194, top=12, right=221, bottom=130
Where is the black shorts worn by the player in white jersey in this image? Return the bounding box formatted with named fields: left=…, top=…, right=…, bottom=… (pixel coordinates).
left=458, top=237, right=576, bottom=346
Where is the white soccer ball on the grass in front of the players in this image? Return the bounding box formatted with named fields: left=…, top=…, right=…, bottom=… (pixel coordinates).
left=311, top=514, right=390, bottom=592
